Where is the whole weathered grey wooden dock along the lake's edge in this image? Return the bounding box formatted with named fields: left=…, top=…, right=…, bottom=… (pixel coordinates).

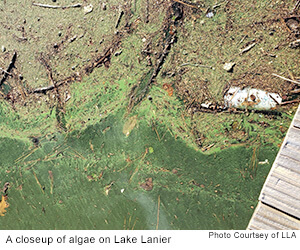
left=247, top=105, right=300, bottom=230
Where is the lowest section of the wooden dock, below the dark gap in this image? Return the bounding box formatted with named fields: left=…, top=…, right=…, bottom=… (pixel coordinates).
left=247, top=202, right=300, bottom=230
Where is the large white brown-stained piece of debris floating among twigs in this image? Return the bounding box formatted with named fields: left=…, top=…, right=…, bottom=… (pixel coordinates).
left=224, top=87, right=282, bottom=110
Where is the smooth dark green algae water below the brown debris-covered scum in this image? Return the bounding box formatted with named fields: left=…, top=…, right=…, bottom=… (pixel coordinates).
left=0, top=112, right=277, bottom=229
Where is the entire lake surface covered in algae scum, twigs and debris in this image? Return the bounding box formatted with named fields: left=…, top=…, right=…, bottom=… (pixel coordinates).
left=0, top=0, right=300, bottom=230
